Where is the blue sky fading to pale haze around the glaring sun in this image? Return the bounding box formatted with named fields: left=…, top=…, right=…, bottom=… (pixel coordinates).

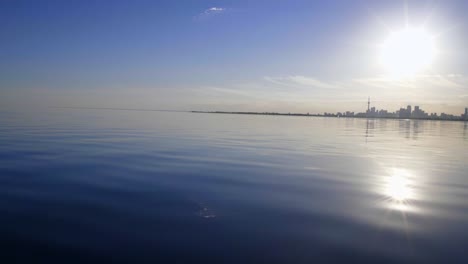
left=0, top=0, right=468, bottom=113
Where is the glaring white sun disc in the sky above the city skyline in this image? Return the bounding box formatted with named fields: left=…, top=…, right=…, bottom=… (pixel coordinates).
left=380, top=27, right=436, bottom=76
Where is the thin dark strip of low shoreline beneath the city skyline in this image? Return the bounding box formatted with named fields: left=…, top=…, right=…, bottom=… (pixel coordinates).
left=190, top=111, right=468, bottom=122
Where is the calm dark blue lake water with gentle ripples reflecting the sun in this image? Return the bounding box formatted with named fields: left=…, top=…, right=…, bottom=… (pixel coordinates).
left=0, top=109, right=468, bottom=263
